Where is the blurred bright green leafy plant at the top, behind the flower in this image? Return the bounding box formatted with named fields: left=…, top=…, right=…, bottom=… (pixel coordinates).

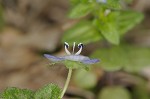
left=62, top=0, right=143, bottom=45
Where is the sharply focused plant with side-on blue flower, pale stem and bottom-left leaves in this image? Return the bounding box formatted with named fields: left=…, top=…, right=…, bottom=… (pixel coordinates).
left=0, top=42, right=99, bottom=99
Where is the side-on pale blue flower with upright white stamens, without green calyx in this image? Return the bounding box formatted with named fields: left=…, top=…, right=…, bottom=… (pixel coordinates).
left=44, top=42, right=99, bottom=65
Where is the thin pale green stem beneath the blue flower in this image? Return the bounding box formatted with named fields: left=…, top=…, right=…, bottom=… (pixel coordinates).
left=60, top=69, right=72, bottom=99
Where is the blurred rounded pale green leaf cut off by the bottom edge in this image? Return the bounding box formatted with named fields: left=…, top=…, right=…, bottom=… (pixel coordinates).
left=98, top=86, right=131, bottom=99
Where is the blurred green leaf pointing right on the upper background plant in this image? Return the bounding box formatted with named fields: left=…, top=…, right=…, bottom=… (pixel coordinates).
left=118, top=10, right=144, bottom=34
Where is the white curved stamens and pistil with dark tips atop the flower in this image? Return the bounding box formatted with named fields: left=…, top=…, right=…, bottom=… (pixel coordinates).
left=64, top=42, right=83, bottom=55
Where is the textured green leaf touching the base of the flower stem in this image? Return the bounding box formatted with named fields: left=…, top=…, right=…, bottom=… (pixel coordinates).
left=34, top=84, right=61, bottom=99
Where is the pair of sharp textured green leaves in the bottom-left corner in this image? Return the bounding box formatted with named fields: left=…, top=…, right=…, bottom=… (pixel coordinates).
left=0, top=84, right=61, bottom=99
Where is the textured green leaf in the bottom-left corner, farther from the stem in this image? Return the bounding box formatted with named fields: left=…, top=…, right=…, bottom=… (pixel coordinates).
left=0, top=87, right=34, bottom=99
